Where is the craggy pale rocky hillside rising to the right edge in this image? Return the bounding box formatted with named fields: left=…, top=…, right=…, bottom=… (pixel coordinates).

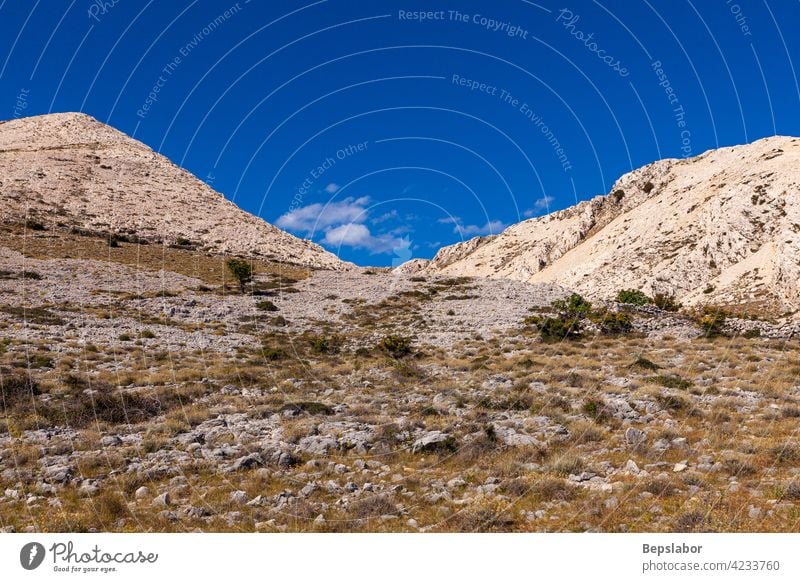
left=400, top=137, right=800, bottom=314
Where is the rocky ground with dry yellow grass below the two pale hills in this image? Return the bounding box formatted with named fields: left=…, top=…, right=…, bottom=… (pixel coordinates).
left=0, top=226, right=800, bottom=532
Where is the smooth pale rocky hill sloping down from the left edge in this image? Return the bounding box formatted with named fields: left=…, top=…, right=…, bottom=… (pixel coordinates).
left=0, top=113, right=350, bottom=269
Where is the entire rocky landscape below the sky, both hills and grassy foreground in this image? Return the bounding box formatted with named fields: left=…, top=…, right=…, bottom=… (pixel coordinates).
left=0, top=114, right=800, bottom=532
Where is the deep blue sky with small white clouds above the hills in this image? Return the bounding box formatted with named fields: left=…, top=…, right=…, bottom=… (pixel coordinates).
left=0, top=0, right=800, bottom=265
